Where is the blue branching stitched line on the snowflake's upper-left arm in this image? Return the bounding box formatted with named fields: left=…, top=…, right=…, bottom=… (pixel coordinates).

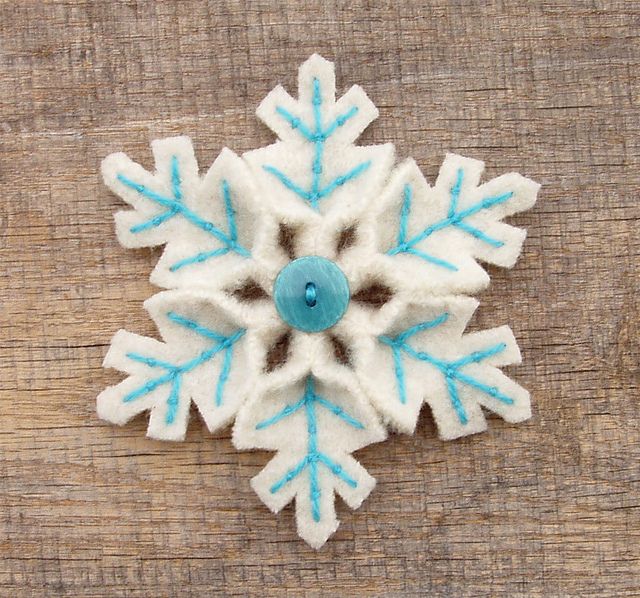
left=117, top=156, right=251, bottom=272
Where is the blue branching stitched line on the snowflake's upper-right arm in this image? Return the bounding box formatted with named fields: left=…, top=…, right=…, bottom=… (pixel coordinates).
left=387, top=168, right=513, bottom=271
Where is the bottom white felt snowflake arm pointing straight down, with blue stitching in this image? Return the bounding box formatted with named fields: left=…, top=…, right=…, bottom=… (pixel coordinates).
left=234, top=374, right=384, bottom=548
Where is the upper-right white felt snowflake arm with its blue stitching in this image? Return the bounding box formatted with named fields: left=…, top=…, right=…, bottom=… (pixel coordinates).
left=371, top=154, right=539, bottom=292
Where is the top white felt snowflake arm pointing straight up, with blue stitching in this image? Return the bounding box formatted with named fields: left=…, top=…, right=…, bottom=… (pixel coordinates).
left=245, top=55, right=393, bottom=217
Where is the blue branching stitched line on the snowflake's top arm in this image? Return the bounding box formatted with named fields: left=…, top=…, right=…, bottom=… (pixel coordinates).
left=263, top=78, right=371, bottom=210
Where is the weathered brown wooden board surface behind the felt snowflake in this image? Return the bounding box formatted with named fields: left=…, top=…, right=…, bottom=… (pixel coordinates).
left=0, top=0, right=640, bottom=597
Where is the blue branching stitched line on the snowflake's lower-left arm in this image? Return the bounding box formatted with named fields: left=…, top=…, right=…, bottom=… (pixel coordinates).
left=122, top=312, right=246, bottom=426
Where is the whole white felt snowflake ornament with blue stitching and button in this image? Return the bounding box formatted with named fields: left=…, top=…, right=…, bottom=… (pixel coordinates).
left=98, top=55, right=539, bottom=548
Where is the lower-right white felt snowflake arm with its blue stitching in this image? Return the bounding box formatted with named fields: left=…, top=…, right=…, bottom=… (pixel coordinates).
left=361, top=297, right=531, bottom=439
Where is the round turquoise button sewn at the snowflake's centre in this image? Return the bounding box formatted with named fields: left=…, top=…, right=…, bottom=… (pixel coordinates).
left=273, top=255, right=350, bottom=332
